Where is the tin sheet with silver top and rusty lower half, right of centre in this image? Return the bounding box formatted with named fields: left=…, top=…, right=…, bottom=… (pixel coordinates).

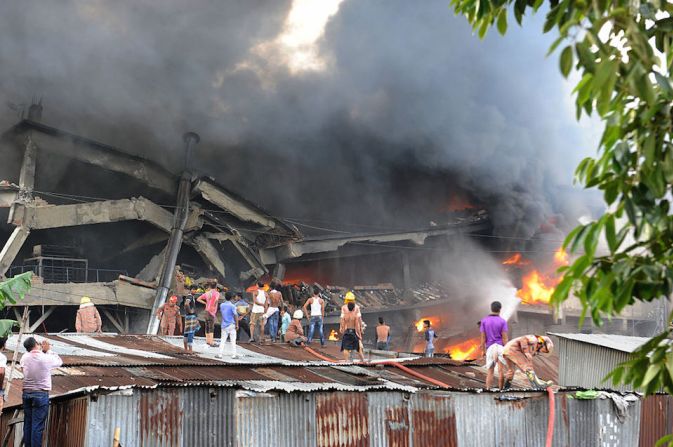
left=411, top=391, right=456, bottom=447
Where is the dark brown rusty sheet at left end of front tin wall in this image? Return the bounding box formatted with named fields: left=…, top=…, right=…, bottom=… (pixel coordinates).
left=47, top=396, right=89, bottom=446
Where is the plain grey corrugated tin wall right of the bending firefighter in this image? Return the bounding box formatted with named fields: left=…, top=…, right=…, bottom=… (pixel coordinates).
left=557, top=337, right=631, bottom=391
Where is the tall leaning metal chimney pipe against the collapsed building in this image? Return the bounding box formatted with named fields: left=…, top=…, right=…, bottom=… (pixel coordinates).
left=147, top=132, right=201, bottom=334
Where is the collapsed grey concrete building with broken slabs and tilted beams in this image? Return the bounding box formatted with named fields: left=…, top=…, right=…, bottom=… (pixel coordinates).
left=0, top=115, right=498, bottom=333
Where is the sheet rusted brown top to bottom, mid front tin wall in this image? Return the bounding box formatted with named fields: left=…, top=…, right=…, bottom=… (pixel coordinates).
left=316, top=392, right=370, bottom=447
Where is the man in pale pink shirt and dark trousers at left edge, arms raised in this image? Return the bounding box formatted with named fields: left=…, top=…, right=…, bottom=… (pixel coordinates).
left=20, top=337, right=63, bottom=447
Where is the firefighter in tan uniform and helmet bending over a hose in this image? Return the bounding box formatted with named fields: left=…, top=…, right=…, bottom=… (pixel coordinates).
left=503, top=335, right=554, bottom=389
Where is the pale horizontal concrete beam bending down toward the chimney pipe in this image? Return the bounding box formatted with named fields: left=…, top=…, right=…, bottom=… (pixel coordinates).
left=13, top=197, right=173, bottom=232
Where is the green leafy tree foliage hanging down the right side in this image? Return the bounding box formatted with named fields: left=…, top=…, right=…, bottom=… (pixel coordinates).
left=451, top=0, right=673, bottom=393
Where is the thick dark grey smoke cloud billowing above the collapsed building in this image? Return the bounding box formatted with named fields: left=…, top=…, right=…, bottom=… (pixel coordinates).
left=0, top=0, right=583, bottom=235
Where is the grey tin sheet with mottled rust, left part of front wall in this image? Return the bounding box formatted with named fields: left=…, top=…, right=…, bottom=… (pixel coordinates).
left=140, top=390, right=183, bottom=446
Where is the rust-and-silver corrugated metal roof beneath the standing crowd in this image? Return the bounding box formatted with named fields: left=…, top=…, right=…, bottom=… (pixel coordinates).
left=0, top=334, right=568, bottom=412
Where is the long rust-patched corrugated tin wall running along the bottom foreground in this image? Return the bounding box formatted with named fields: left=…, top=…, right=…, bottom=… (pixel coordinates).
left=21, top=387, right=640, bottom=447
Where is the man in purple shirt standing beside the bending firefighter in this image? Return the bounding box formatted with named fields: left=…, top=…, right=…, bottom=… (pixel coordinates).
left=479, top=301, right=509, bottom=389
